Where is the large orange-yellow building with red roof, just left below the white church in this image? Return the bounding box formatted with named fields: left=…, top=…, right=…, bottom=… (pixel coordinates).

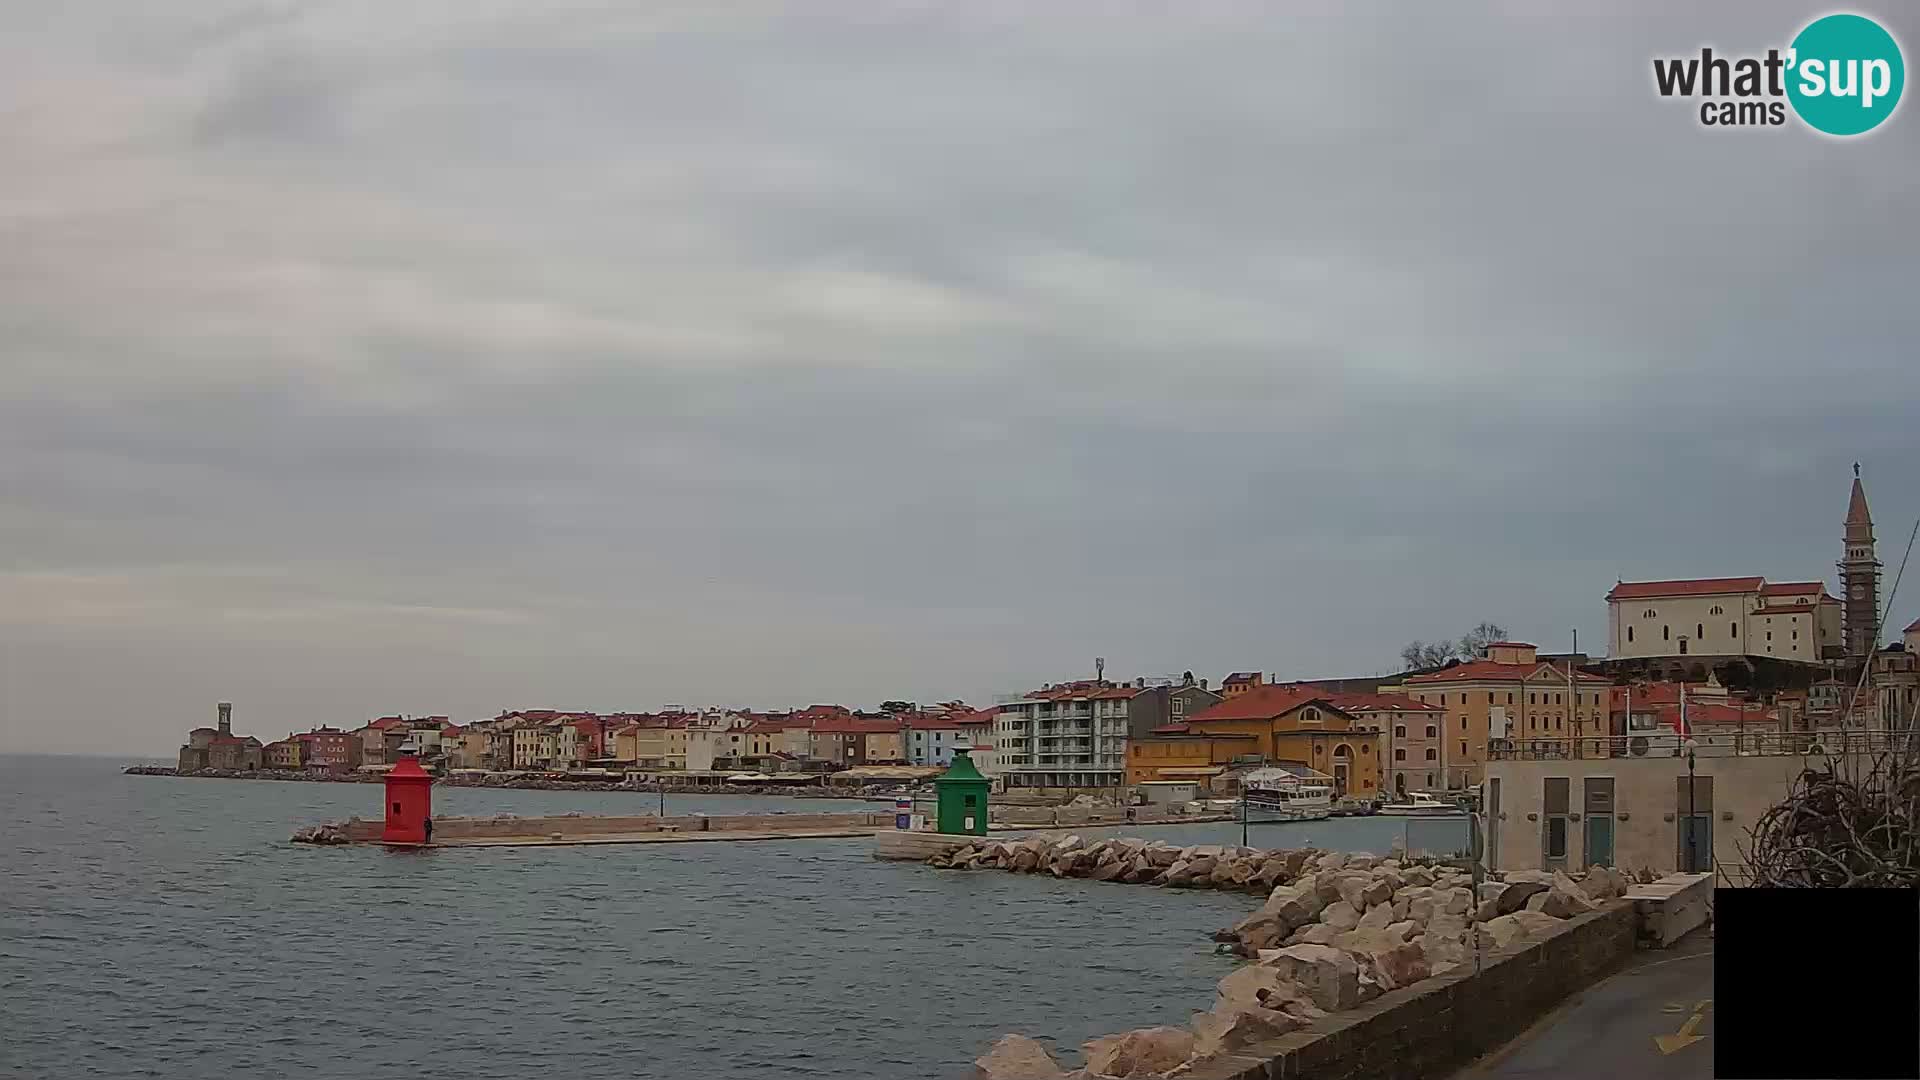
left=1380, top=642, right=1611, bottom=788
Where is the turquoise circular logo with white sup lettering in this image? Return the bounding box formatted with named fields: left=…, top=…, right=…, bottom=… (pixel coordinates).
left=1788, top=15, right=1907, bottom=135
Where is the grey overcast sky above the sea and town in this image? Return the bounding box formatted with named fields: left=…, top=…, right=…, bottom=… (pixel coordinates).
left=0, top=0, right=1920, bottom=753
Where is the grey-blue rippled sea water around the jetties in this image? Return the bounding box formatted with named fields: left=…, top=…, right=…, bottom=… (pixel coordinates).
left=0, top=755, right=1466, bottom=1080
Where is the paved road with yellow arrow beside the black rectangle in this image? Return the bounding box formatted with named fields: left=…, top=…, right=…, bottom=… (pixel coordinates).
left=1455, top=928, right=1713, bottom=1080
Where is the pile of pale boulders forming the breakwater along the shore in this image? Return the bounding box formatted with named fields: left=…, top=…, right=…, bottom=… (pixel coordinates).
left=927, top=836, right=1630, bottom=1080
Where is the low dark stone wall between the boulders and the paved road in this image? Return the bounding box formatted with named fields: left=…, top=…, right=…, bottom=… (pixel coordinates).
left=1183, top=899, right=1638, bottom=1080
